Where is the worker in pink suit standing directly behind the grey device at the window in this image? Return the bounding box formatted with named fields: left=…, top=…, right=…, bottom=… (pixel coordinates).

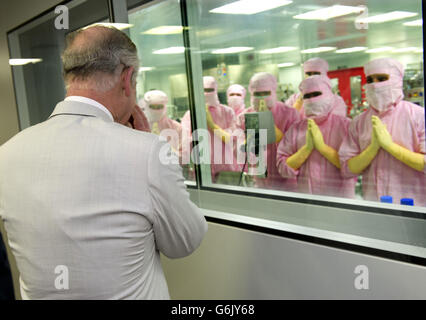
left=238, top=72, right=300, bottom=191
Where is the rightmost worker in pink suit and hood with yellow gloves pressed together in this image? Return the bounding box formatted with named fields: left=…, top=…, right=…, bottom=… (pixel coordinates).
left=339, top=58, right=426, bottom=206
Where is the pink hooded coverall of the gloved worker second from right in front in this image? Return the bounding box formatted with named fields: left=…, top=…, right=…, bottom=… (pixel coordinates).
left=276, top=75, right=355, bottom=198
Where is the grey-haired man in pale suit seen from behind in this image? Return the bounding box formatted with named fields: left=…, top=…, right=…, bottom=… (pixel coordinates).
left=0, top=26, right=207, bottom=299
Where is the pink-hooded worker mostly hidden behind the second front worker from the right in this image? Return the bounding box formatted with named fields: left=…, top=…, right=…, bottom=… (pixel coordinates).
left=285, top=58, right=348, bottom=117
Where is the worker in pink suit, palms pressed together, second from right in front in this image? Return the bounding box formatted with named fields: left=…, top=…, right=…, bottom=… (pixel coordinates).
left=277, top=75, right=355, bottom=198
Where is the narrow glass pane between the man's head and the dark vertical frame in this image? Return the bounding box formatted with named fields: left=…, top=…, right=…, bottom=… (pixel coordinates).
left=128, top=0, right=195, bottom=184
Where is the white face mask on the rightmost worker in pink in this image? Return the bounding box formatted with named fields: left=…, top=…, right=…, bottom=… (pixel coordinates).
left=365, top=83, right=402, bottom=113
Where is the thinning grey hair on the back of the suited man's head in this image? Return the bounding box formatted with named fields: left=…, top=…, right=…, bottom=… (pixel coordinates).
left=62, top=25, right=139, bottom=92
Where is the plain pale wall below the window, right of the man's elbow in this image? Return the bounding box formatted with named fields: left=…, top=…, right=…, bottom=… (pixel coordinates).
left=162, top=223, right=426, bottom=300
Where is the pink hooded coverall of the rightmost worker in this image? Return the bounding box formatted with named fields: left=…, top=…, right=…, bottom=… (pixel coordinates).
left=339, top=58, right=426, bottom=206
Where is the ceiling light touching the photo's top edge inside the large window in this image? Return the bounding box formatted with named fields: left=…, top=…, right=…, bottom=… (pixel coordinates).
left=210, top=0, right=293, bottom=14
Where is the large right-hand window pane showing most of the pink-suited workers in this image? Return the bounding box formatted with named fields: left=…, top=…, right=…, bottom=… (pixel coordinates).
left=187, top=0, right=426, bottom=210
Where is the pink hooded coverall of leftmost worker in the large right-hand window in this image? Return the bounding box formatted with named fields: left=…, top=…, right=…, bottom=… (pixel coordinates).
left=182, top=76, right=244, bottom=182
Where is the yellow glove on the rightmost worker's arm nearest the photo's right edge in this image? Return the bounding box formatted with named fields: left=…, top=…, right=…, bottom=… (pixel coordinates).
left=371, top=116, right=425, bottom=172
